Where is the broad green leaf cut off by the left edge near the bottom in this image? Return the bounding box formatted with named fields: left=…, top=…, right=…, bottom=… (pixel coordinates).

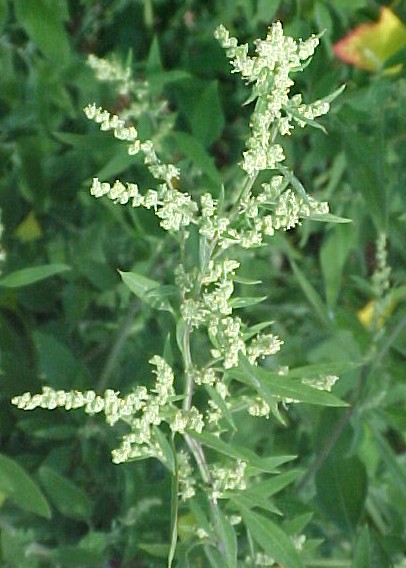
left=0, top=454, right=51, bottom=519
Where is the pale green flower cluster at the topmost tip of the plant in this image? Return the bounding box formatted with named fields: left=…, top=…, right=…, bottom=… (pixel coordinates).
left=214, top=22, right=329, bottom=177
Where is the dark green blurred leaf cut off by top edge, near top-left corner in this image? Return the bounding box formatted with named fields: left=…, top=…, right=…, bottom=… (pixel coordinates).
left=14, top=0, right=70, bottom=62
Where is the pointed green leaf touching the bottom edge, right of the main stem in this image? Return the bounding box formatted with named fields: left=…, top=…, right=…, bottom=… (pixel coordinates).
left=241, top=507, right=303, bottom=568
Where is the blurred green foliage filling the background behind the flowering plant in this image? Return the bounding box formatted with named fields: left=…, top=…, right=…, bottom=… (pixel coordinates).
left=0, top=0, right=406, bottom=568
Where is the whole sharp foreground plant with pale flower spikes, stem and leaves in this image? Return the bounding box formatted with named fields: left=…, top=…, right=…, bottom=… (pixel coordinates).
left=12, top=22, right=351, bottom=568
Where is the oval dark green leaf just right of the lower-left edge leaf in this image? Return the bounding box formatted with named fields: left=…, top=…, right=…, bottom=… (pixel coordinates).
left=39, top=466, right=92, bottom=521
